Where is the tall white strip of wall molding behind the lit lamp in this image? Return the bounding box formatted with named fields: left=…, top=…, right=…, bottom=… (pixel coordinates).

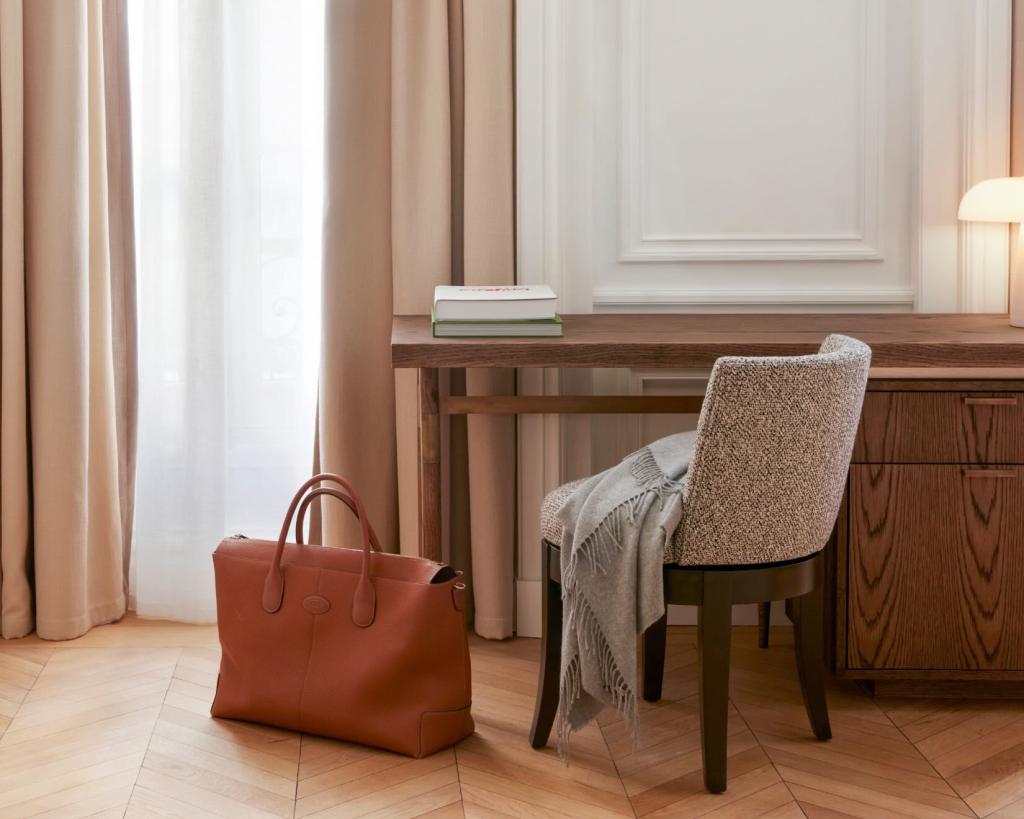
left=912, top=0, right=1012, bottom=312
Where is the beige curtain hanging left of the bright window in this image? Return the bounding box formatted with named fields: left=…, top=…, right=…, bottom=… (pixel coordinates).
left=0, top=0, right=135, bottom=640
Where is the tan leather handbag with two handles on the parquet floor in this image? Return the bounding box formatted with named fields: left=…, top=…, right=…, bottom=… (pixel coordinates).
left=210, top=474, right=473, bottom=757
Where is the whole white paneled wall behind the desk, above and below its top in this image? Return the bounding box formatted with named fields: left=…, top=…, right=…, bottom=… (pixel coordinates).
left=517, top=0, right=1011, bottom=629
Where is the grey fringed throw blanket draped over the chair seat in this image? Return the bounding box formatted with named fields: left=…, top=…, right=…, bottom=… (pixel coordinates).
left=557, top=432, right=695, bottom=759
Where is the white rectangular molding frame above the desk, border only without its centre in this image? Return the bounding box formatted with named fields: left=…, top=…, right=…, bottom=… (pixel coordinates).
left=618, top=0, right=885, bottom=262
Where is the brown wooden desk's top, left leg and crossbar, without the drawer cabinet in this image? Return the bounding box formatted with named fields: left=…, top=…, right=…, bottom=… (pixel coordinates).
left=391, top=313, right=1024, bottom=559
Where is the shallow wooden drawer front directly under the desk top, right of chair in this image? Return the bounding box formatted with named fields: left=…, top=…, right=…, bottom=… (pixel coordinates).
left=853, top=392, right=1024, bottom=464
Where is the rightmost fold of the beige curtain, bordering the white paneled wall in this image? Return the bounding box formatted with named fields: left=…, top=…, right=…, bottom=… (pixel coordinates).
left=462, top=0, right=516, bottom=637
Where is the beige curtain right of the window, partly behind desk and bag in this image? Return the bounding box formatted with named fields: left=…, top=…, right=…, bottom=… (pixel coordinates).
left=319, top=0, right=515, bottom=638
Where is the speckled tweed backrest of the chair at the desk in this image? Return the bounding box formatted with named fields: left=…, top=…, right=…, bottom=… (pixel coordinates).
left=673, top=335, right=871, bottom=565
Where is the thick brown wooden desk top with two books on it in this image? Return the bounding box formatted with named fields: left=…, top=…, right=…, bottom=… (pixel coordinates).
left=391, top=313, right=1024, bottom=369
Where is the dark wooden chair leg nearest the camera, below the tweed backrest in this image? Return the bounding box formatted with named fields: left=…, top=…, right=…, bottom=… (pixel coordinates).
left=697, top=571, right=732, bottom=793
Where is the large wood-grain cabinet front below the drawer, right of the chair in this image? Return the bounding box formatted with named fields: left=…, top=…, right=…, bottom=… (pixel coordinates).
left=847, top=465, right=1024, bottom=671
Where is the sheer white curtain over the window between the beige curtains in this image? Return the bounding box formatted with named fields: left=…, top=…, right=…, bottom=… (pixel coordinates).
left=129, top=0, right=324, bottom=621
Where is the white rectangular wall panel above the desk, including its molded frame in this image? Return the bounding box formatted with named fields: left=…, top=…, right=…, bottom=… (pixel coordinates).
left=620, top=0, right=885, bottom=261
